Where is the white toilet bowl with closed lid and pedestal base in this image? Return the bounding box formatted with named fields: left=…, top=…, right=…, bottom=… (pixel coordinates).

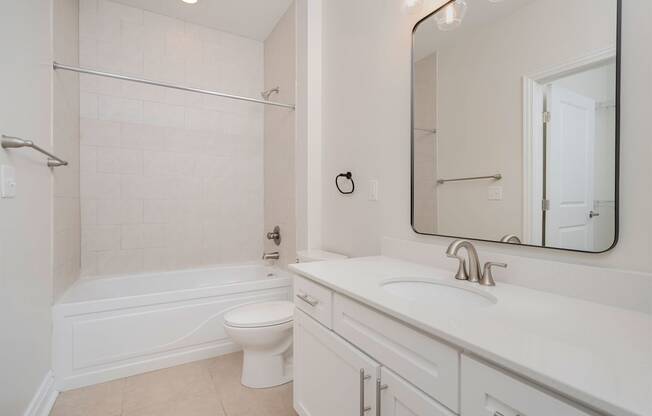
left=224, top=301, right=294, bottom=389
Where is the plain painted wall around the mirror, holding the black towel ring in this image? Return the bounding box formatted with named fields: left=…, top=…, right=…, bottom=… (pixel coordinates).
left=323, top=0, right=652, bottom=276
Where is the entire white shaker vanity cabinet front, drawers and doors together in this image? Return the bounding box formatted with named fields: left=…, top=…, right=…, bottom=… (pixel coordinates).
left=294, top=277, right=595, bottom=416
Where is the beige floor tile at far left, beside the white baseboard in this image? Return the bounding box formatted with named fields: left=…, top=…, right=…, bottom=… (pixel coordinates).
left=50, top=379, right=125, bottom=416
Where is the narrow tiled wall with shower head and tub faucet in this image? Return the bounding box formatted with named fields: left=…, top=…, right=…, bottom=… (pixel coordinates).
left=264, top=4, right=297, bottom=266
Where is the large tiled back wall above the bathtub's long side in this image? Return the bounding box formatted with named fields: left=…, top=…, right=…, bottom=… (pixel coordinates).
left=79, top=0, right=264, bottom=275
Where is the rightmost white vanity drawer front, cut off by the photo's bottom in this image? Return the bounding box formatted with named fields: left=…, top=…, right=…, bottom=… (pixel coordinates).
left=462, top=356, right=593, bottom=416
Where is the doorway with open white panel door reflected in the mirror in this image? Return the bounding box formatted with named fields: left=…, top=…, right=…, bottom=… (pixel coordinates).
left=524, top=58, right=616, bottom=251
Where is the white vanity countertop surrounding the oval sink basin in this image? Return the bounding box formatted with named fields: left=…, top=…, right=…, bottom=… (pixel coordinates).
left=290, top=257, right=652, bottom=416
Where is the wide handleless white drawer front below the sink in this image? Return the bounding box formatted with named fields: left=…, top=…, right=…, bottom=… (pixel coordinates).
left=333, top=294, right=460, bottom=416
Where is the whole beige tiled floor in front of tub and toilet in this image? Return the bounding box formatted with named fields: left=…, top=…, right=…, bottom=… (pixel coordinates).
left=50, top=353, right=296, bottom=416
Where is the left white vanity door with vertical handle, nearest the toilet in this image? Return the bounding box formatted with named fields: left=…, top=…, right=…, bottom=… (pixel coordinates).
left=294, top=310, right=380, bottom=416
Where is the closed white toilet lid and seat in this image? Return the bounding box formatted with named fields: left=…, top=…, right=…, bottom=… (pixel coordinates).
left=224, top=301, right=294, bottom=328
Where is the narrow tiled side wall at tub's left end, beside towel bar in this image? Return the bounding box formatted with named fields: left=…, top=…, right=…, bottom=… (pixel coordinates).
left=52, top=0, right=81, bottom=300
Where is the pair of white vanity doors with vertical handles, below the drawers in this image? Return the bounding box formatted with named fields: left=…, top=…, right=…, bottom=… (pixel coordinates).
left=294, top=311, right=454, bottom=416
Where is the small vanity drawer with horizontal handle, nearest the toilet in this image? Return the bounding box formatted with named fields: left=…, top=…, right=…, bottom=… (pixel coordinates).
left=294, top=276, right=333, bottom=329
